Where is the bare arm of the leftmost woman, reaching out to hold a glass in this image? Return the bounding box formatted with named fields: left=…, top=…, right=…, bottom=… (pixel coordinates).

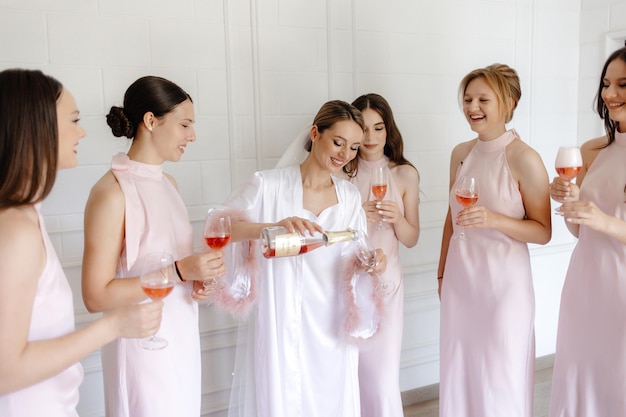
left=0, top=208, right=163, bottom=395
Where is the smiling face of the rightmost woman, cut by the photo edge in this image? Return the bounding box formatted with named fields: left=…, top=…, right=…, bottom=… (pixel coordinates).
left=601, top=58, right=626, bottom=132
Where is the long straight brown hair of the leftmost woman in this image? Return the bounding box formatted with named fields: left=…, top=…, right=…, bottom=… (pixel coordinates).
left=0, top=68, right=63, bottom=209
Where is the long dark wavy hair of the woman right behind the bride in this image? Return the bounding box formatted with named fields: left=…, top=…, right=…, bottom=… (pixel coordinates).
left=348, top=93, right=415, bottom=176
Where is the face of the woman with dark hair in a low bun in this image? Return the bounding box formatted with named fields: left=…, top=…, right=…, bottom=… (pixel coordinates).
left=147, top=100, right=196, bottom=162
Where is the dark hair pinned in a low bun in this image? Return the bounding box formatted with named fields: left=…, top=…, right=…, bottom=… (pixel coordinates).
left=107, top=75, right=193, bottom=139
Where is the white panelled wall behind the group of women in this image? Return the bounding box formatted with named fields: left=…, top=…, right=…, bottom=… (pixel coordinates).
left=0, top=0, right=626, bottom=416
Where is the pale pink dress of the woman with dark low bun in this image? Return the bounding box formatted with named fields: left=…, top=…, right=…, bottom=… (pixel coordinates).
left=102, top=153, right=201, bottom=417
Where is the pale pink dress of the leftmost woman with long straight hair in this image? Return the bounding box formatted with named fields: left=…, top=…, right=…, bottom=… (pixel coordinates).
left=0, top=204, right=83, bottom=417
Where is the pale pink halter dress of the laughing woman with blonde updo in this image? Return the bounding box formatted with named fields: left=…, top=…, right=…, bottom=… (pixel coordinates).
left=439, top=130, right=535, bottom=417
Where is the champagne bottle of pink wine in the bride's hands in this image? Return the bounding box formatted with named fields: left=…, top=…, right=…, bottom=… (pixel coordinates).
left=261, top=226, right=360, bottom=258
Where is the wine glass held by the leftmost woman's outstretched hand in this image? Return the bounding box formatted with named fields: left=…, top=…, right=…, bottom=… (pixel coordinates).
left=139, top=252, right=177, bottom=350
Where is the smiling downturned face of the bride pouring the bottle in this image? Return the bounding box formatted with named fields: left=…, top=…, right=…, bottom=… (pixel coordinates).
left=311, top=120, right=363, bottom=173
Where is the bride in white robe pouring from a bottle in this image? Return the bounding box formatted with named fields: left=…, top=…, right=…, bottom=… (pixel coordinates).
left=226, top=101, right=386, bottom=417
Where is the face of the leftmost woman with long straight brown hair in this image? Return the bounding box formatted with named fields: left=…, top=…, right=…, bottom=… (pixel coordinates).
left=57, top=89, right=85, bottom=169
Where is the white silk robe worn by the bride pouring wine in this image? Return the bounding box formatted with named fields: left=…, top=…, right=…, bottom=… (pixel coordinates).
left=227, top=166, right=367, bottom=417
